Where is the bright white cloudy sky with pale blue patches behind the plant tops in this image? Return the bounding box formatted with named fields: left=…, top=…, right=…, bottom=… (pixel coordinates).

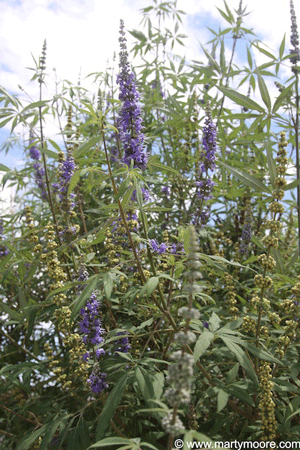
left=0, top=0, right=300, bottom=174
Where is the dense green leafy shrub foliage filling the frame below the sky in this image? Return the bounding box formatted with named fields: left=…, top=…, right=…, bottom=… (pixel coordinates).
left=0, top=0, right=300, bottom=450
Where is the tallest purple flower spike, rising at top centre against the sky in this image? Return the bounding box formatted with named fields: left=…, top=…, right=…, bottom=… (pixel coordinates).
left=117, top=20, right=148, bottom=169
